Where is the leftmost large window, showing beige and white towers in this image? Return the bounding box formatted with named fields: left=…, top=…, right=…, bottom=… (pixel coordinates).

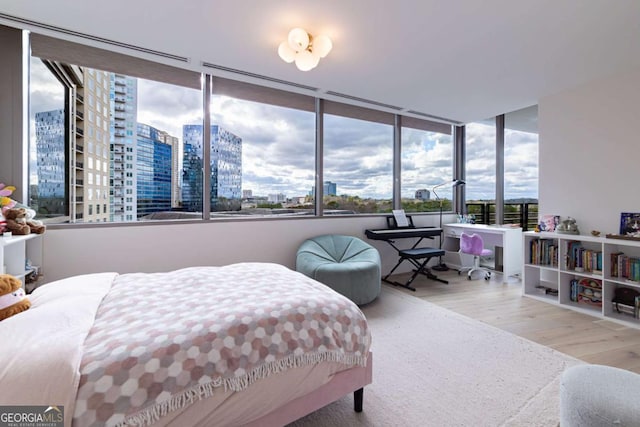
left=29, top=36, right=202, bottom=223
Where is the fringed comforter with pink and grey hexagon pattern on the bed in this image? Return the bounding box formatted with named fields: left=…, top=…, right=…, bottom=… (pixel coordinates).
left=73, top=263, right=370, bottom=426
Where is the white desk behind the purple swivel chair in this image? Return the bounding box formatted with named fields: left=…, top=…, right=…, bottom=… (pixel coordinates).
left=442, top=224, right=523, bottom=282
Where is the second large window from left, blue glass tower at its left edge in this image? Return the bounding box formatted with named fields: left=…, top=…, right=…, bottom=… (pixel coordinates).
left=210, top=78, right=315, bottom=218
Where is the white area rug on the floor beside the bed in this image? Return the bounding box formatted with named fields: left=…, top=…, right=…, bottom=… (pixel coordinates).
left=291, top=286, right=583, bottom=427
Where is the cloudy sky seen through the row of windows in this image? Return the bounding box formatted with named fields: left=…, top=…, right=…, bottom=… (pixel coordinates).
left=31, top=60, right=538, bottom=199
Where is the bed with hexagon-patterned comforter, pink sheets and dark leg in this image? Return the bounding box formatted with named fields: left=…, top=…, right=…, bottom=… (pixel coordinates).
left=0, top=263, right=372, bottom=427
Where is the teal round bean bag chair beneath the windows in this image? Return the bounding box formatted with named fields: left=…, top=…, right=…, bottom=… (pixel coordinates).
left=296, top=234, right=381, bottom=305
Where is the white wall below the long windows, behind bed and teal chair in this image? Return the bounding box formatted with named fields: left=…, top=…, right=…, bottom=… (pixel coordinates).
left=43, top=215, right=453, bottom=282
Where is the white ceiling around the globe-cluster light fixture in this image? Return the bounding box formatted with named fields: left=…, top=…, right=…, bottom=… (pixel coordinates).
left=0, top=0, right=640, bottom=123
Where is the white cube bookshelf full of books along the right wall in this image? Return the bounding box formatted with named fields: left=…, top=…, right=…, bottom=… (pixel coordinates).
left=522, top=231, right=640, bottom=328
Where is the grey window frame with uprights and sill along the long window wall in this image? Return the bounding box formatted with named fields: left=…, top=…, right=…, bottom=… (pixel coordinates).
left=24, top=28, right=464, bottom=228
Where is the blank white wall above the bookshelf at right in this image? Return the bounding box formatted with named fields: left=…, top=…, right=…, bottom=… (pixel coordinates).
left=538, top=65, right=640, bottom=234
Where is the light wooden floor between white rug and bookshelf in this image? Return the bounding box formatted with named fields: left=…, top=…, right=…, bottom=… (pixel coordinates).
left=390, top=270, right=640, bottom=373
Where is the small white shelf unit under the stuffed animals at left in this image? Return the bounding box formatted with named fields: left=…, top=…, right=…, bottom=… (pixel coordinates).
left=0, top=234, right=42, bottom=287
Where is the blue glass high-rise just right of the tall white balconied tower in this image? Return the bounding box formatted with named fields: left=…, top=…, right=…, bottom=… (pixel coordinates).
left=135, top=123, right=177, bottom=218
